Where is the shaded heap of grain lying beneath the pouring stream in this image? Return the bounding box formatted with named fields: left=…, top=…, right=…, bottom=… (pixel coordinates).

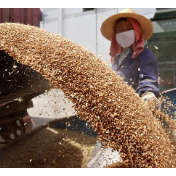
left=0, top=127, right=97, bottom=168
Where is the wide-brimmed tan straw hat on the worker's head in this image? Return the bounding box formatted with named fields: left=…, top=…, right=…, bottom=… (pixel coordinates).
left=101, top=9, right=153, bottom=41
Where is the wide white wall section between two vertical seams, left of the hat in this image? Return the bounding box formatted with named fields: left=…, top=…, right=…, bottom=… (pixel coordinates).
left=62, top=9, right=96, bottom=53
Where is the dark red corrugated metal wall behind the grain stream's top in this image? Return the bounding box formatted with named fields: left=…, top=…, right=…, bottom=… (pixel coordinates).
left=0, top=8, right=40, bottom=27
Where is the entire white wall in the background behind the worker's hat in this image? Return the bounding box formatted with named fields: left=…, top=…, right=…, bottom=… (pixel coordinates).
left=40, top=8, right=156, bottom=66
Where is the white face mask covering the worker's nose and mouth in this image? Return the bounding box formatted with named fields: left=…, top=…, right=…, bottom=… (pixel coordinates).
left=116, top=30, right=135, bottom=48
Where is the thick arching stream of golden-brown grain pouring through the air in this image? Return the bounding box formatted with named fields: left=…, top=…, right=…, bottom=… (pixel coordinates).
left=0, top=23, right=176, bottom=168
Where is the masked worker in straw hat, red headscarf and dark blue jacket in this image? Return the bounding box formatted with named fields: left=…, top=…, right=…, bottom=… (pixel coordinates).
left=101, top=9, right=160, bottom=101
